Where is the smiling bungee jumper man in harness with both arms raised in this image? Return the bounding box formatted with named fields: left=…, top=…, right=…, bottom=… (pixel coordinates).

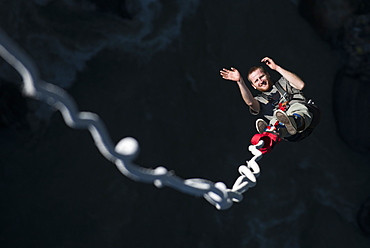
left=220, top=57, right=313, bottom=140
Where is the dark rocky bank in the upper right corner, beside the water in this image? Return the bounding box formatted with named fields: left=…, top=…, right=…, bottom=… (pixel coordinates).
left=299, top=0, right=370, bottom=155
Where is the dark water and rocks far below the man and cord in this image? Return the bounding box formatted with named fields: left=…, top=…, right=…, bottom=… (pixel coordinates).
left=0, top=0, right=370, bottom=248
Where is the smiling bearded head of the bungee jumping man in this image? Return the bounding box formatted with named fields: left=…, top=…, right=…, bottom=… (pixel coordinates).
left=248, top=66, right=273, bottom=92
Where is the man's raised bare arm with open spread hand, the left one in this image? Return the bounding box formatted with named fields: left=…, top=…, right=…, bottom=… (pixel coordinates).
left=220, top=67, right=260, bottom=113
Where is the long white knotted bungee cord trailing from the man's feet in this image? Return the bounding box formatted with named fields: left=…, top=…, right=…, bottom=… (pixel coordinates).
left=0, top=29, right=263, bottom=209
